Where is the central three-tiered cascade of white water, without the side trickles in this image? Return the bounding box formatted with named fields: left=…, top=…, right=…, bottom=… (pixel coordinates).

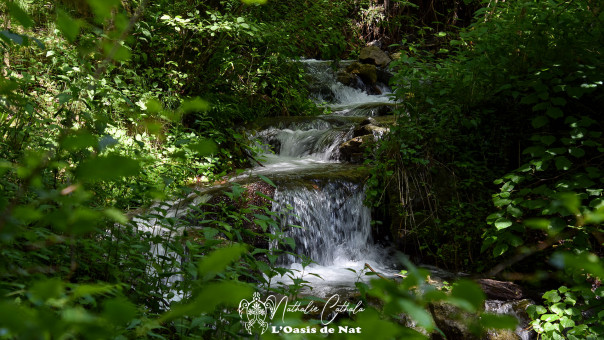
left=243, top=60, right=394, bottom=295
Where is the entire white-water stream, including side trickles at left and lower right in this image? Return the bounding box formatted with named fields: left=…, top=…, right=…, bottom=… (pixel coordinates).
left=134, top=60, right=532, bottom=339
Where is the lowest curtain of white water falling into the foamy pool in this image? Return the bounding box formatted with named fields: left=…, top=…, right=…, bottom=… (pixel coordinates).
left=273, top=181, right=374, bottom=266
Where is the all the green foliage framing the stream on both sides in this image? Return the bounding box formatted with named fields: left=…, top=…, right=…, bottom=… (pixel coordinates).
left=0, top=0, right=604, bottom=338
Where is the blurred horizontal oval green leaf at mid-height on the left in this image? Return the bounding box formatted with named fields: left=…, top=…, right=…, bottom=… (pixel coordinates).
left=76, top=155, right=141, bottom=182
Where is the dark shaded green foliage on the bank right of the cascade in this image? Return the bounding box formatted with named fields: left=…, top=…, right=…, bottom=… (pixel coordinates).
left=366, top=2, right=602, bottom=274
